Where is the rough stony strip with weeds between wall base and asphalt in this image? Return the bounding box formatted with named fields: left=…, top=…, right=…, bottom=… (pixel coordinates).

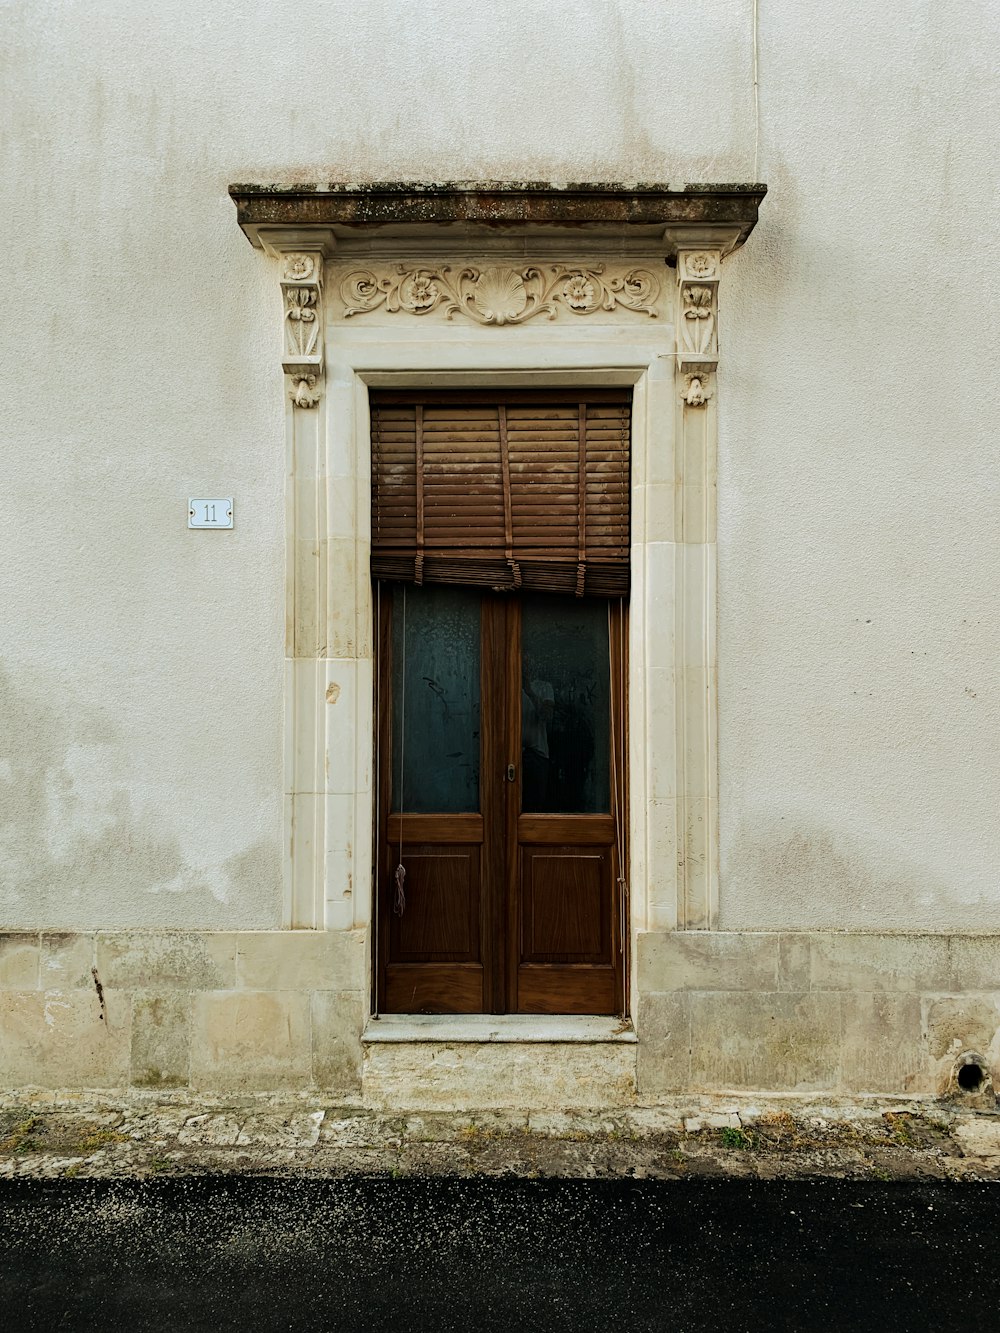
left=0, top=1090, right=1000, bottom=1180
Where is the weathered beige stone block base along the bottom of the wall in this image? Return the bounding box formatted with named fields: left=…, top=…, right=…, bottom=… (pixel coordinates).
left=0, top=930, right=1000, bottom=1113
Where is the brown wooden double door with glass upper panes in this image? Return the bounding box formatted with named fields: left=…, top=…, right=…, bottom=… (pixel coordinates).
left=376, top=584, right=625, bottom=1014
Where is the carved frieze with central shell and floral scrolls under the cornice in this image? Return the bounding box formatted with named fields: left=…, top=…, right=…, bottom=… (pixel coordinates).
left=340, top=264, right=660, bottom=327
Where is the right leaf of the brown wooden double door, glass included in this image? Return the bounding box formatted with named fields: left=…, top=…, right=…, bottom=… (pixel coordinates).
left=511, top=596, right=623, bottom=1013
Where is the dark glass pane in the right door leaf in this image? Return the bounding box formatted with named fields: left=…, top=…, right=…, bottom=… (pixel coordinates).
left=521, top=595, right=611, bottom=814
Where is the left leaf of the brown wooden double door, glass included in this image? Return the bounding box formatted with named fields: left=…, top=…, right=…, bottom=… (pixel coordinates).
left=376, top=588, right=496, bottom=1013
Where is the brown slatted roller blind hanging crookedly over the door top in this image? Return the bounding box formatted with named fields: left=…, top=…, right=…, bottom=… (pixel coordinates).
left=371, top=389, right=631, bottom=596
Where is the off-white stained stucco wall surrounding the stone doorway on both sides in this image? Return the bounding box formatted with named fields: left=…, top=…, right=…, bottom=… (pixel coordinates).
left=0, top=0, right=1000, bottom=928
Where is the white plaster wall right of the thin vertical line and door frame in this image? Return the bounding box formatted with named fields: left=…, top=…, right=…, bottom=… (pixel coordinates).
left=719, top=0, right=1000, bottom=929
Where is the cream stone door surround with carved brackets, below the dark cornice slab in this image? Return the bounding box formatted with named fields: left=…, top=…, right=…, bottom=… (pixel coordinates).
left=233, top=187, right=756, bottom=1013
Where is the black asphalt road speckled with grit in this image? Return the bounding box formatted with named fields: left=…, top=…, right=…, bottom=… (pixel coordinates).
left=0, top=1177, right=1000, bottom=1333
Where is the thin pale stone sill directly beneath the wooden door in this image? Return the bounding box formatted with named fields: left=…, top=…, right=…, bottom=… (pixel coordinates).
left=361, top=1013, right=637, bottom=1044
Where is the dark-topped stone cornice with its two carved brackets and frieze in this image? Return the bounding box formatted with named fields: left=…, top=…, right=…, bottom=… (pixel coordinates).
left=229, top=181, right=767, bottom=408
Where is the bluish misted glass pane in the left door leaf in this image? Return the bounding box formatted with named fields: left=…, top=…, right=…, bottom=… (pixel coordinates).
left=391, top=585, right=481, bottom=814
